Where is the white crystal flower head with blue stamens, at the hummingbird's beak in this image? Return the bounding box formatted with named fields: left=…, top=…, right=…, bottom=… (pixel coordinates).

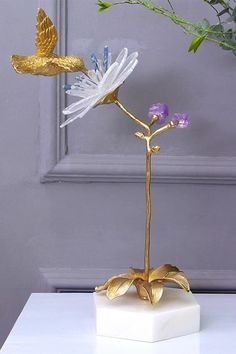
left=61, top=47, right=138, bottom=128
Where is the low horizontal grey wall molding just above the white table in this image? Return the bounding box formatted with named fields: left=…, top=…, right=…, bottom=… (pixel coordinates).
left=40, top=268, right=236, bottom=291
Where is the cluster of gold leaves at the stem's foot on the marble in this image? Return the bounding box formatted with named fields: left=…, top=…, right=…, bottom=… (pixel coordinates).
left=95, top=264, right=190, bottom=305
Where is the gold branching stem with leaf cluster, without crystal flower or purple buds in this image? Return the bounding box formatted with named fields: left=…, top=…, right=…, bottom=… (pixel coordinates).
left=95, top=98, right=190, bottom=304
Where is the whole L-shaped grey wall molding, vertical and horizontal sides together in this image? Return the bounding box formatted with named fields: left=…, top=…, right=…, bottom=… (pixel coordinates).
left=39, top=0, right=236, bottom=184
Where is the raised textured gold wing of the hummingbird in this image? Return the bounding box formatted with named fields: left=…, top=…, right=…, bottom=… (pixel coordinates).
left=35, top=9, right=58, bottom=57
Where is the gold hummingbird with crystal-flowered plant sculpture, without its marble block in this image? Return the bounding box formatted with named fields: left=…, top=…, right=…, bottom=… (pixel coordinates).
left=12, top=9, right=190, bottom=304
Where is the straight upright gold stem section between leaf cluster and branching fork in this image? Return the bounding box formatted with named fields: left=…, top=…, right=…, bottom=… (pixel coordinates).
left=144, top=146, right=152, bottom=281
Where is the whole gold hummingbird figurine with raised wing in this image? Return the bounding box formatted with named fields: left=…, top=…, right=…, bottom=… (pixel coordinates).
left=11, top=9, right=87, bottom=76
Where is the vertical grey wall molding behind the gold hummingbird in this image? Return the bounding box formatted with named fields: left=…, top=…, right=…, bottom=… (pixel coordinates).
left=39, top=0, right=67, bottom=181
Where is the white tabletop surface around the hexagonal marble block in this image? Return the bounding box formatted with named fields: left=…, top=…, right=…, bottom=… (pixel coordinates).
left=0, top=293, right=236, bottom=354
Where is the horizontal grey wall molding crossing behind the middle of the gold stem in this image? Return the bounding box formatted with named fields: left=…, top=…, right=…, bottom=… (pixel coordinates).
left=42, top=154, right=236, bottom=184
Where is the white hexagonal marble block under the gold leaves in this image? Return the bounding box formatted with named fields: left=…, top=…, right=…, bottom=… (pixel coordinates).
left=94, top=288, right=200, bottom=342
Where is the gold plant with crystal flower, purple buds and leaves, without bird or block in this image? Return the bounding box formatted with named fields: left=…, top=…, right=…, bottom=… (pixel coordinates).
left=61, top=47, right=189, bottom=304
